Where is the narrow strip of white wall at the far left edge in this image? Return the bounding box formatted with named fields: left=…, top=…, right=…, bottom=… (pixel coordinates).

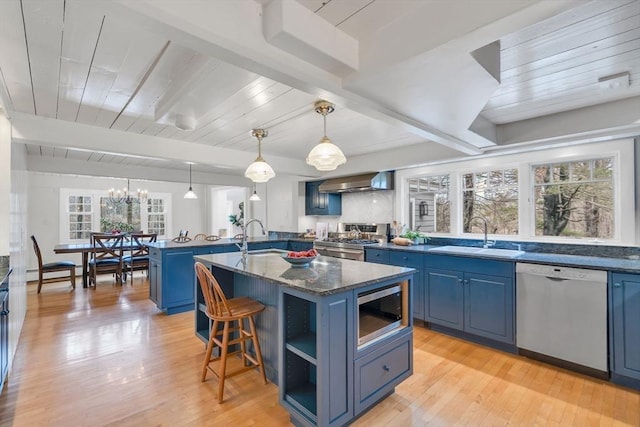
left=9, top=144, right=31, bottom=374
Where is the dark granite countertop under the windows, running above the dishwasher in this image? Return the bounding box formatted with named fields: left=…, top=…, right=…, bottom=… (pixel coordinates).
left=367, top=243, right=640, bottom=274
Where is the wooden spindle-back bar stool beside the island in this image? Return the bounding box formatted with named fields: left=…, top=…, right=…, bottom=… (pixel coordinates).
left=195, top=262, right=267, bottom=403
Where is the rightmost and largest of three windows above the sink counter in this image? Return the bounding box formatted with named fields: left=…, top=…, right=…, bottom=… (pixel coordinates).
left=533, top=157, right=615, bottom=239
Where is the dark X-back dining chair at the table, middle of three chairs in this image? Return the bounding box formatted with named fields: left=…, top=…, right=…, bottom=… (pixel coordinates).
left=89, top=233, right=124, bottom=287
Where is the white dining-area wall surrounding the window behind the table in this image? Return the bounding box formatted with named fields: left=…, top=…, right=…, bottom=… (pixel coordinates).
left=27, top=172, right=206, bottom=270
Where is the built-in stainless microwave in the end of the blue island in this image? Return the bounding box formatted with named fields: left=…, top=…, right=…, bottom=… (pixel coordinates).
left=357, top=282, right=409, bottom=347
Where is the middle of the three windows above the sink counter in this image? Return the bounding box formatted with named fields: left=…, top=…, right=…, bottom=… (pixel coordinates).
left=462, top=169, right=518, bottom=235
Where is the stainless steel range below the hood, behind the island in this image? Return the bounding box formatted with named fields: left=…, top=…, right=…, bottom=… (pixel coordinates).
left=313, top=223, right=390, bottom=261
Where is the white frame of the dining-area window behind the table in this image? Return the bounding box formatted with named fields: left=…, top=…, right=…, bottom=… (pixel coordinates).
left=59, top=188, right=172, bottom=244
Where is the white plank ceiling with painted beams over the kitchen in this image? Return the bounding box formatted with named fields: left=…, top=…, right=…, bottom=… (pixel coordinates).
left=0, top=0, right=640, bottom=181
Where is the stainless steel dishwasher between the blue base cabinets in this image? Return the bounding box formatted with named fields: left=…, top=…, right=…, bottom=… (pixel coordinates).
left=516, top=263, right=608, bottom=377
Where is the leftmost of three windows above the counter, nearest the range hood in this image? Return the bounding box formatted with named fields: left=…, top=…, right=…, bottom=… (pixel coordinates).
left=409, top=174, right=451, bottom=233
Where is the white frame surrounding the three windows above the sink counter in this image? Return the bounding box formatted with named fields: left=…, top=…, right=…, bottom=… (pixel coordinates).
left=394, top=139, right=637, bottom=246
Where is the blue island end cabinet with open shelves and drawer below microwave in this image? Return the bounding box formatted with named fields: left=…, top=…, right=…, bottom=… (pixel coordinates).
left=278, top=282, right=413, bottom=426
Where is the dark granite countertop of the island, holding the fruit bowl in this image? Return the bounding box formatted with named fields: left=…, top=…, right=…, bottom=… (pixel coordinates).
left=194, top=252, right=415, bottom=295
